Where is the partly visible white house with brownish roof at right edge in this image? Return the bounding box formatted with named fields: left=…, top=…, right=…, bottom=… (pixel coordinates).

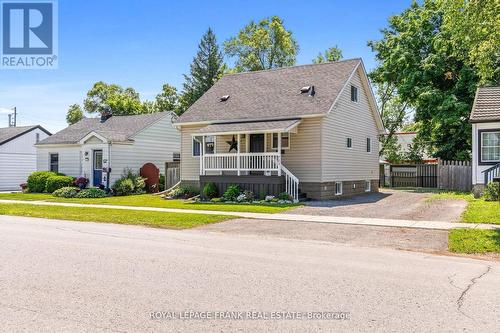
left=469, top=86, right=500, bottom=187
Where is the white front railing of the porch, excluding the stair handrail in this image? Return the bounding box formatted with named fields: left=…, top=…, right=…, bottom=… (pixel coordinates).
left=202, top=153, right=281, bottom=172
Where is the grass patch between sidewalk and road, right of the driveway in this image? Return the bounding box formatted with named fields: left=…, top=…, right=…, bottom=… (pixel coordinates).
left=448, top=229, right=500, bottom=253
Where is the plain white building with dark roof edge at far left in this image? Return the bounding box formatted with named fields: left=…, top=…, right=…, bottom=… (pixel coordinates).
left=0, top=125, right=51, bottom=191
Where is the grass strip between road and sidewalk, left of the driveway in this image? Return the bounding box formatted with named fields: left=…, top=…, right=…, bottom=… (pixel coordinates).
left=0, top=204, right=234, bottom=229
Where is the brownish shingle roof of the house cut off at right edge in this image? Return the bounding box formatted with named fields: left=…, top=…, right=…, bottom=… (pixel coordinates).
left=469, top=86, right=500, bottom=123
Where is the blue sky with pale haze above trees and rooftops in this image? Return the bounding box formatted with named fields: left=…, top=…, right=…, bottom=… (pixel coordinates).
left=0, top=0, right=411, bottom=132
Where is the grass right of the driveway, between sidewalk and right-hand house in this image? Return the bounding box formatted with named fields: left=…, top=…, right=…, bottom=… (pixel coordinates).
left=427, top=192, right=500, bottom=224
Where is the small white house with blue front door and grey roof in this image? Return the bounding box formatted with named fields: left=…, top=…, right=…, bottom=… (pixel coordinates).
left=36, top=112, right=180, bottom=186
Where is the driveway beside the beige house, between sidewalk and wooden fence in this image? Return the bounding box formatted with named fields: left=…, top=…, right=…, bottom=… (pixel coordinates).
left=287, top=189, right=467, bottom=222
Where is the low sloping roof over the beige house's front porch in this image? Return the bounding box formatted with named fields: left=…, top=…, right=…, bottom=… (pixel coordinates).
left=193, top=119, right=301, bottom=135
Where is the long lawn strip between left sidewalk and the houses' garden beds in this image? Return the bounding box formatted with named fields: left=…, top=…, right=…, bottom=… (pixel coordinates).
left=0, top=193, right=298, bottom=213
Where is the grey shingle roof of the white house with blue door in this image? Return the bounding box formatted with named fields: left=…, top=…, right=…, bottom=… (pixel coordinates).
left=38, top=112, right=170, bottom=145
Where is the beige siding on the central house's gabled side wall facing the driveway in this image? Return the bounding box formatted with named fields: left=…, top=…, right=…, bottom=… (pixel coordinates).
left=321, top=69, right=379, bottom=182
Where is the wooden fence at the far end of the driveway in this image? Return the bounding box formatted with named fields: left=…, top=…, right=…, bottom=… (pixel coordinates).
left=386, top=160, right=472, bottom=191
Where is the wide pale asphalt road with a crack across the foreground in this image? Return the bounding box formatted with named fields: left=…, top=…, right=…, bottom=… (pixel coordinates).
left=0, top=216, right=500, bottom=332
